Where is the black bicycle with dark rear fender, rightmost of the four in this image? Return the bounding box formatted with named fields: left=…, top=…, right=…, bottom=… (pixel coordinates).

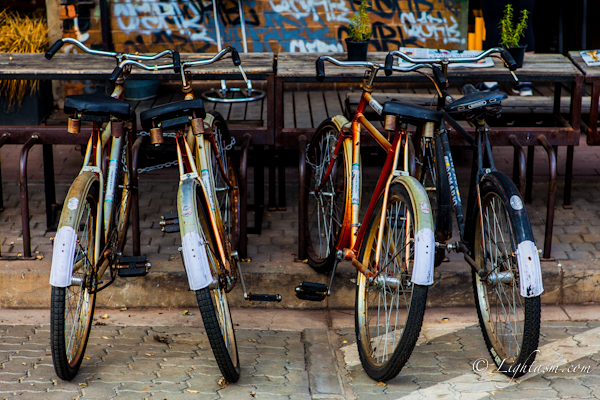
left=385, top=48, right=543, bottom=378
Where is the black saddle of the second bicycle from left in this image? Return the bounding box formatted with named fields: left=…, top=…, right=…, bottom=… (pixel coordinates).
left=140, top=99, right=206, bottom=131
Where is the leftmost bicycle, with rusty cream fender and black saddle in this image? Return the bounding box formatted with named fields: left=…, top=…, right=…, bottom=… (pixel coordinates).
left=45, top=38, right=173, bottom=380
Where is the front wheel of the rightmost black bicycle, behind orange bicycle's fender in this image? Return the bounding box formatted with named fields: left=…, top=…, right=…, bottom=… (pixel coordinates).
left=415, top=136, right=452, bottom=267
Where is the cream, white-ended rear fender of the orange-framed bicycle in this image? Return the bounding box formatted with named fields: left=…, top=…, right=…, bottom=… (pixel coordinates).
left=392, top=176, right=435, bottom=285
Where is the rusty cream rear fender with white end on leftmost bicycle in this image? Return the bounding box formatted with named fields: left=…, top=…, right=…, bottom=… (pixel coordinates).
left=50, top=172, right=101, bottom=287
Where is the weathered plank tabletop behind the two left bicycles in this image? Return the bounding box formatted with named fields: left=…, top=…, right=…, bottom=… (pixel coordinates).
left=0, top=53, right=275, bottom=79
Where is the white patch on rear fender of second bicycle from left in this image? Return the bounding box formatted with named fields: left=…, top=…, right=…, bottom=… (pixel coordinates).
left=181, top=232, right=212, bottom=290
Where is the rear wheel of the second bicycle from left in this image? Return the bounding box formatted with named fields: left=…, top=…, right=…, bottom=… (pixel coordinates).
left=195, top=186, right=241, bottom=383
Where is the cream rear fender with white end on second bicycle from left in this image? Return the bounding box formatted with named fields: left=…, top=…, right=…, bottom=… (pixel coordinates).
left=177, top=178, right=213, bottom=290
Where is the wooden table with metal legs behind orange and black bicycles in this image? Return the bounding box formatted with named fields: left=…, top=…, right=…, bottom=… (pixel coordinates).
left=275, top=53, right=583, bottom=259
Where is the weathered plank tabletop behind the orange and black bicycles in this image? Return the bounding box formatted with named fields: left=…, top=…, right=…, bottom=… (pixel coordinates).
left=277, top=52, right=582, bottom=82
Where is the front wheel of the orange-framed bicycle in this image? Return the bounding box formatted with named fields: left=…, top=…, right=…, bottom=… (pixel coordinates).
left=305, top=119, right=352, bottom=273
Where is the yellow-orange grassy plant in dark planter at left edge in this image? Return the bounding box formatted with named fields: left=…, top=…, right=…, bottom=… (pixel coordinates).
left=0, top=10, right=54, bottom=125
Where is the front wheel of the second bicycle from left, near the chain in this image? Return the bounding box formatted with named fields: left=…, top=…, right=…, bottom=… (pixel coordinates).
left=209, top=111, right=240, bottom=249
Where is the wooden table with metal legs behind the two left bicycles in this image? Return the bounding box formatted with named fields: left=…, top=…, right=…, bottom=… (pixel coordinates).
left=0, top=53, right=275, bottom=258
